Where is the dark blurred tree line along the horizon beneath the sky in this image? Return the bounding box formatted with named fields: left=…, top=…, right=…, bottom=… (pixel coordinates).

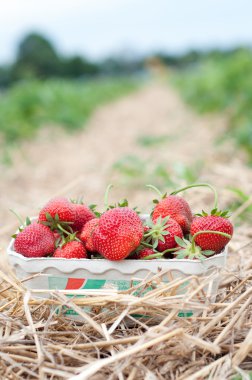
left=0, top=33, right=248, bottom=88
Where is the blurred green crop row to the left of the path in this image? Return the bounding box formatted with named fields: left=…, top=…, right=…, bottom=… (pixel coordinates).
left=0, top=78, right=137, bottom=143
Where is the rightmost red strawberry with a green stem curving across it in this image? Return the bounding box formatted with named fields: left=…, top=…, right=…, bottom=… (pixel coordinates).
left=191, top=214, right=233, bottom=253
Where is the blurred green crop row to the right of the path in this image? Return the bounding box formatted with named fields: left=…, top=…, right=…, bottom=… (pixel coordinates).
left=174, top=49, right=252, bottom=160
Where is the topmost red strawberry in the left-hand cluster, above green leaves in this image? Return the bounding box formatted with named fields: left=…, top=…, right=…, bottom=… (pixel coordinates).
left=38, top=197, right=76, bottom=229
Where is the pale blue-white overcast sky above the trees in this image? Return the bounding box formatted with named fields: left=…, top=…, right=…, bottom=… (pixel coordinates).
left=0, top=0, right=252, bottom=63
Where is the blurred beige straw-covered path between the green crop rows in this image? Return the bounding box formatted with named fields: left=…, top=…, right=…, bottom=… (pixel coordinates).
left=0, top=84, right=252, bottom=249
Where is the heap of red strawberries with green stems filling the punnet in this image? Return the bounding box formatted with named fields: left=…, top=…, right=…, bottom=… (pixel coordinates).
left=11, top=184, right=233, bottom=260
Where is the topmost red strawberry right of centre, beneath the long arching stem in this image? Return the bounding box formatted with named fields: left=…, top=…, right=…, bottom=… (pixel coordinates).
left=152, top=195, right=193, bottom=234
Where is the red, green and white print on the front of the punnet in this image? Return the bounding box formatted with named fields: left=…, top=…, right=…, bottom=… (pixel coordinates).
left=48, top=276, right=193, bottom=318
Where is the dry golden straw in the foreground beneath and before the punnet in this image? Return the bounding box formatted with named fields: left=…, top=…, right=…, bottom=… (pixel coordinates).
left=0, top=235, right=252, bottom=380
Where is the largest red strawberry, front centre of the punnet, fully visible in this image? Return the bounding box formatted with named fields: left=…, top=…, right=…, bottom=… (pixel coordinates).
left=93, top=207, right=143, bottom=260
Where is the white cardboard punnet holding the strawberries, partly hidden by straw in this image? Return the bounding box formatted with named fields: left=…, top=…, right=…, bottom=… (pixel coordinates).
left=7, top=235, right=227, bottom=320
